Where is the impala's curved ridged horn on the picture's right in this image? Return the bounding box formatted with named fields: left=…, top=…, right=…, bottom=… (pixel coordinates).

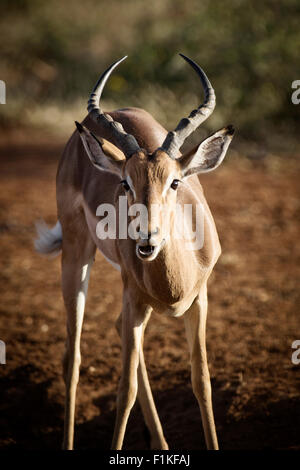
left=161, top=54, right=216, bottom=159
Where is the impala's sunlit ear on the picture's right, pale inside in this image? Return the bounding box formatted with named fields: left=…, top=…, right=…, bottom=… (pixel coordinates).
left=178, top=126, right=234, bottom=178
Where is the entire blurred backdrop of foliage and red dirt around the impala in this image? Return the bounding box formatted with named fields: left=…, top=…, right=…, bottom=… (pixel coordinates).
left=0, top=0, right=300, bottom=449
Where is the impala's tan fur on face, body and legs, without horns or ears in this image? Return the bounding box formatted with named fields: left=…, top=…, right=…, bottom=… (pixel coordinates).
left=57, top=108, right=221, bottom=449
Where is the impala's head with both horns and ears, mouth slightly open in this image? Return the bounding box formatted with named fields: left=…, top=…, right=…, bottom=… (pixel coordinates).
left=76, top=54, right=234, bottom=261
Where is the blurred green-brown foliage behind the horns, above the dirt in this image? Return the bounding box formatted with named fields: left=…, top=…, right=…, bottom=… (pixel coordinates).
left=0, top=0, right=300, bottom=148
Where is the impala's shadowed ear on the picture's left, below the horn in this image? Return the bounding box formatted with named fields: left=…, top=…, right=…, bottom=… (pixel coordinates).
left=75, top=121, right=125, bottom=175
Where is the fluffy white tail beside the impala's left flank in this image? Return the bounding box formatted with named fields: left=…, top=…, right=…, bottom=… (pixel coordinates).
left=34, top=220, right=62, bottom=256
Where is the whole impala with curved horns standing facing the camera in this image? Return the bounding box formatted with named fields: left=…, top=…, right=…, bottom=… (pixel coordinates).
left=36, top=54, right=234, bottom=449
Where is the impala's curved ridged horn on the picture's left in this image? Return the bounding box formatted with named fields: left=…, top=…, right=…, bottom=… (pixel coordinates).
left=88, top=56, right=140, bottom=158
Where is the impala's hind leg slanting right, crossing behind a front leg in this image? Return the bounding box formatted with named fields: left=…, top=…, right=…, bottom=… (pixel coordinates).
left=116, top=313, right=169, bottom=450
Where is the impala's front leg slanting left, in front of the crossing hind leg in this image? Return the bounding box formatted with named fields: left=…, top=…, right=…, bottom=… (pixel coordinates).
left=112, top=298, right=150, bottom=450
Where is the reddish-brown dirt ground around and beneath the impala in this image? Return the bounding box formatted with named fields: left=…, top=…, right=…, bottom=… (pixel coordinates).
left=0, top=135, right=300, bottom=449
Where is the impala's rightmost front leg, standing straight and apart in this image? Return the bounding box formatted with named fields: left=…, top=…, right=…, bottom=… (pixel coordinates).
left=184, top=285, right=218, bottom=450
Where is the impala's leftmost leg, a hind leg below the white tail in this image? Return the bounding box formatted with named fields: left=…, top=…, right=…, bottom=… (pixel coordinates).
left=62, top=227, right=95, bottom=449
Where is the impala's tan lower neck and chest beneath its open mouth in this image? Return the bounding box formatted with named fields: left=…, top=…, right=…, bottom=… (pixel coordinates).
left=120, top=187, right=221, bottom=310
